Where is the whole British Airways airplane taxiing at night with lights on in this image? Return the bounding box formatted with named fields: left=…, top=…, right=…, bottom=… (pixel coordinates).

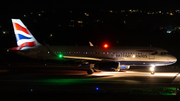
left=9, top=19, right=177, bottom=74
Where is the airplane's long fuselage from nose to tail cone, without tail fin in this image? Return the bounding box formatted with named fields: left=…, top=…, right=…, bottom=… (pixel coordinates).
left=15, top=45, right=177, bottom=66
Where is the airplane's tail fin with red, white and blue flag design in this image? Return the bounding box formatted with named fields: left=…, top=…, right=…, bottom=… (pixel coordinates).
left=12, top=19, right=40, bottom=50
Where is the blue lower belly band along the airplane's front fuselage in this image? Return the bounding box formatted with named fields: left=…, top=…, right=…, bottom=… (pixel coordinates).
left=116, top=61, right=175, bottom=66
